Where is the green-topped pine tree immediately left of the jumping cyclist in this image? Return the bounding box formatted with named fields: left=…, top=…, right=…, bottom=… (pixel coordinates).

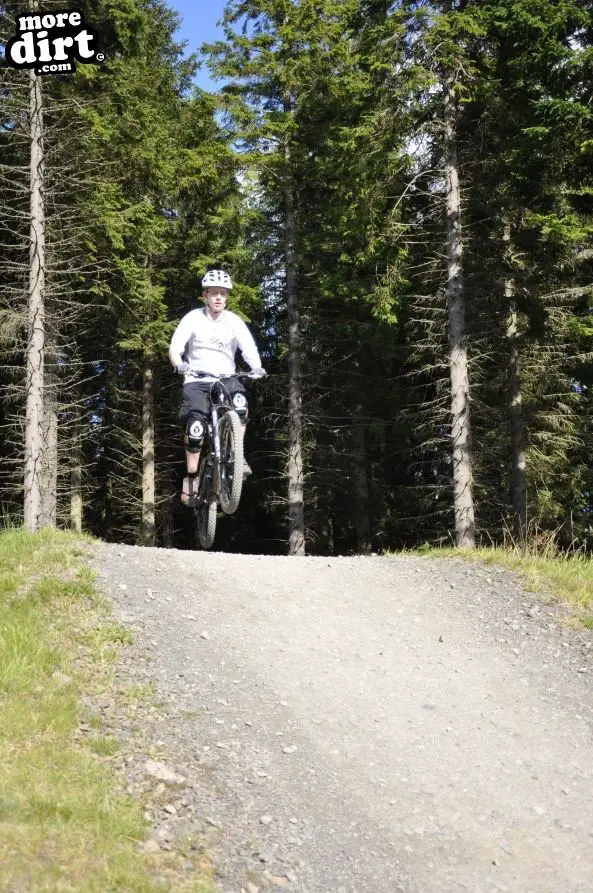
left=67, top=0, right=232, bottom=545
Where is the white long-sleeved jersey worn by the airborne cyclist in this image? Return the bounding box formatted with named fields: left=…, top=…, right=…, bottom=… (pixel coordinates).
left=169, top=307, right=261, bottom=383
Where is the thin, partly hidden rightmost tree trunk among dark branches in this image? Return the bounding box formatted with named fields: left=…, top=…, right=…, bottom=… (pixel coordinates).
left=503, top=222, right=527, bottom=540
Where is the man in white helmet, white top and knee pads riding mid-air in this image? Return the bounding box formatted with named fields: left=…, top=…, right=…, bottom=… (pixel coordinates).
left=169, top=270, right=266, bottom=506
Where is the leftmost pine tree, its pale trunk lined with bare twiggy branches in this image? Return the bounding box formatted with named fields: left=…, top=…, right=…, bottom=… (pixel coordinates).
left=0, top=3, right=103, bottom=530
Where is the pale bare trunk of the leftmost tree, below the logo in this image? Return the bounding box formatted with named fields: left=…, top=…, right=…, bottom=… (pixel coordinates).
left=24, top=70, right=45, bottom=532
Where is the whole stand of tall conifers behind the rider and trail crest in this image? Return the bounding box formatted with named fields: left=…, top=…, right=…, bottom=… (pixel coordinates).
left=0, top=0, right=593, bottom=555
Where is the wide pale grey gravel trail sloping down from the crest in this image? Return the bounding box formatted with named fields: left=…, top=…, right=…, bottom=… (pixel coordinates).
left=90, top=544, right=593, bottom=893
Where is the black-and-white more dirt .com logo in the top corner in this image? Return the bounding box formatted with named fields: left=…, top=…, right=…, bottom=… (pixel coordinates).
left=5, top=9, right=105, bottom=74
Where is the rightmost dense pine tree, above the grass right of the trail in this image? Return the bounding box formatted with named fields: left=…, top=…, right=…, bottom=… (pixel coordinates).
left=464, top=0, right=590, bottom=538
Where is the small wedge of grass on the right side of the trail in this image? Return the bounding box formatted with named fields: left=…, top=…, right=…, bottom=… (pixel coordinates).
left=412, top=537, right=593, bottom=629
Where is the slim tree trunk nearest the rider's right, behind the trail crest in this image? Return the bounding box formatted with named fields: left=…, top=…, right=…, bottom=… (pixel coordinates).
left=284, top=121, right=305, bottom=555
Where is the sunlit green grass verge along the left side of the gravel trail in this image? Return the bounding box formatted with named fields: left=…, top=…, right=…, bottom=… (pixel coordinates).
left=0, top=529, right=214, bottom=893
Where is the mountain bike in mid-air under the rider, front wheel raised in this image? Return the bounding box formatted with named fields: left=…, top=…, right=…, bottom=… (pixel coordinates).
left=188, top=372, right=260, bottom=549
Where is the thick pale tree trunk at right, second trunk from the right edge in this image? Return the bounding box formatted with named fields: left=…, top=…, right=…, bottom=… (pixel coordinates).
left=444, top=80, right=475, bottom=548
